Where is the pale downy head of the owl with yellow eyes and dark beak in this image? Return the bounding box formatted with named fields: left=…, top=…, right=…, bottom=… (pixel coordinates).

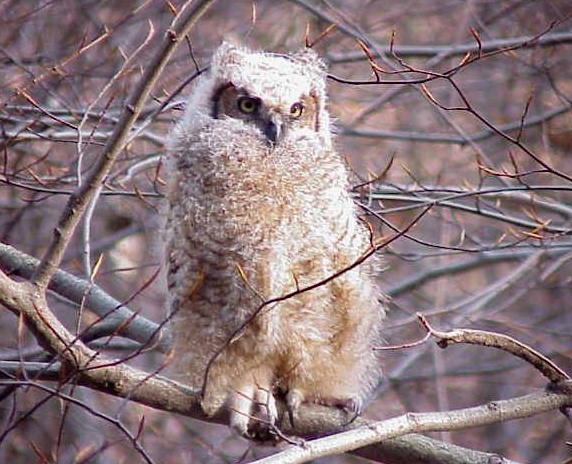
left=179, top=42, right=330, bottom=146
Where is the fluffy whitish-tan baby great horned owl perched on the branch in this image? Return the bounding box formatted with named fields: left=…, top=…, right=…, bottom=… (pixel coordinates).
left=165, top=43, right=383, bottom=434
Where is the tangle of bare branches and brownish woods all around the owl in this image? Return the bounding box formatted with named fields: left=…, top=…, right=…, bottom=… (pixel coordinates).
left=0, top=0, right=572, bottom=464
